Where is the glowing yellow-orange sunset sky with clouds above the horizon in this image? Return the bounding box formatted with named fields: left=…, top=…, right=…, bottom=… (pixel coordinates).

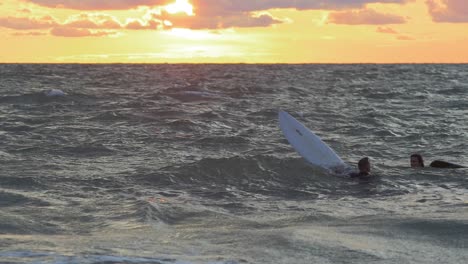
left=0, top=0, right=468, bottom=63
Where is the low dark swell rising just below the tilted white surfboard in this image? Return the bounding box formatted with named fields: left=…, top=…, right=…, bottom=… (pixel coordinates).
left=130, top=155, right=406, bottom=199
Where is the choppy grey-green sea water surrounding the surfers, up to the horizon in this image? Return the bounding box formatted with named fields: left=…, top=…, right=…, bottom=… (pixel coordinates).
left=0, top=64, right=468, bottom=264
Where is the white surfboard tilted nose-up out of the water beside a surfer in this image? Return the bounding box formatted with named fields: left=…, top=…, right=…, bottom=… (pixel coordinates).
left=279, top=111, right=346, bottom=170
